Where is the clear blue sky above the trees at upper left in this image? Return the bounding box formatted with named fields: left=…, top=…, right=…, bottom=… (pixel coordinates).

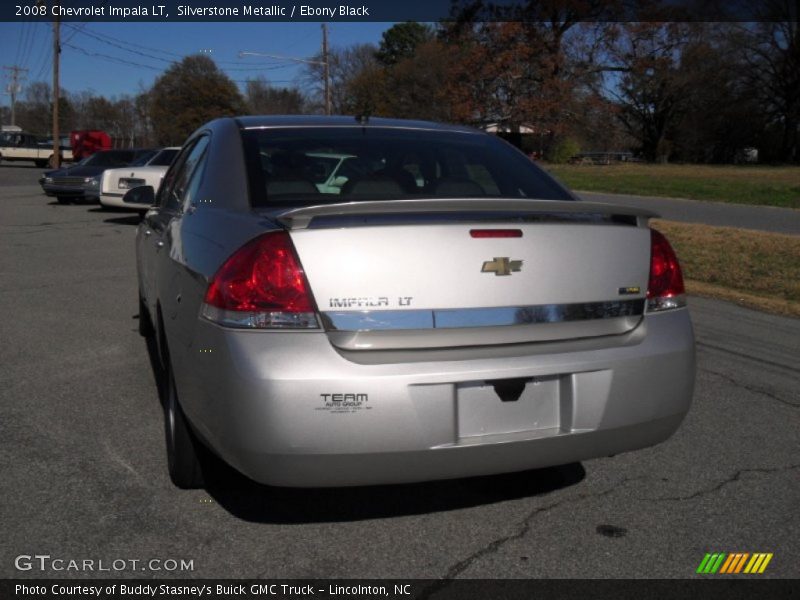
left=0, top=21, right=392, bottom=106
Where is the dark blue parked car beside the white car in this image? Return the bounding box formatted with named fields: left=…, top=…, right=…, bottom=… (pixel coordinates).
left=39, top=149, right=156, bottom=204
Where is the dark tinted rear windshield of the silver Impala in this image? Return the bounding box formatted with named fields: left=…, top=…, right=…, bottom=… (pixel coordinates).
left=242, top=126, right=572, bottom=206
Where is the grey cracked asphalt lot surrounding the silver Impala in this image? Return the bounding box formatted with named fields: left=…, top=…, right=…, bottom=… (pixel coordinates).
left=0, top=165, right=800, bottom=587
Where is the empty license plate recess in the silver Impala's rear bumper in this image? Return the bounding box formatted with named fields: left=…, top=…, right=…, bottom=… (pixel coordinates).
left=456, top=376, right=561, bottom=438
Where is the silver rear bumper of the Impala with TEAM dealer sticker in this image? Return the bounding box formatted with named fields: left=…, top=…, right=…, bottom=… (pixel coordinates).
left=173, top=309, right=695, bottom=487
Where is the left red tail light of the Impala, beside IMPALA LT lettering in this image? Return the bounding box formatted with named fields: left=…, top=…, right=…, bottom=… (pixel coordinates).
left=202, top=231, right=319, bottom=329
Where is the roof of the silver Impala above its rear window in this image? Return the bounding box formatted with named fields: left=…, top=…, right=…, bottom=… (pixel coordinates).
left=235, top=115, right=483, bottom=133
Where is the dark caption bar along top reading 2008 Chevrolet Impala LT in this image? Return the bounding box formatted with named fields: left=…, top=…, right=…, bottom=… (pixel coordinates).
left=0, top=0, right=798, bottom=23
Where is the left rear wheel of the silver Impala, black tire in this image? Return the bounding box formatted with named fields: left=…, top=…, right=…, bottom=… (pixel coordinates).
left=164, top=363, right=203, bottom=489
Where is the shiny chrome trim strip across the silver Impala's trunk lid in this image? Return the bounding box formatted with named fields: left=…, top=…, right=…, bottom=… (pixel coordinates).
left=320, top=298, right=644, bottom=331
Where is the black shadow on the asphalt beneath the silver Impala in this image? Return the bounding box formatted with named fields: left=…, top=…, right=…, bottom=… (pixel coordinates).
left=138, top=315, right=586, bottom=524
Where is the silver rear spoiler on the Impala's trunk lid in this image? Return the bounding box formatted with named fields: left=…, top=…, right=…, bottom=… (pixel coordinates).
left=269, top=198, right=658, bottom=229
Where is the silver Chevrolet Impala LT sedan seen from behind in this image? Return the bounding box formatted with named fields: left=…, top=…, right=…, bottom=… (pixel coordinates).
left=129, top=117, right=695, bottom=487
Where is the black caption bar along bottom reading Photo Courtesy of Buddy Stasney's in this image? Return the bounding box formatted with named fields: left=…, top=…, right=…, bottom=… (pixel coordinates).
left=0, top=575, right=800, bottom=600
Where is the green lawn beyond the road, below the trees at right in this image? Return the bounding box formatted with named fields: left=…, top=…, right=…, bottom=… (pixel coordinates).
left=543, top=163, right=800, bottom=208
